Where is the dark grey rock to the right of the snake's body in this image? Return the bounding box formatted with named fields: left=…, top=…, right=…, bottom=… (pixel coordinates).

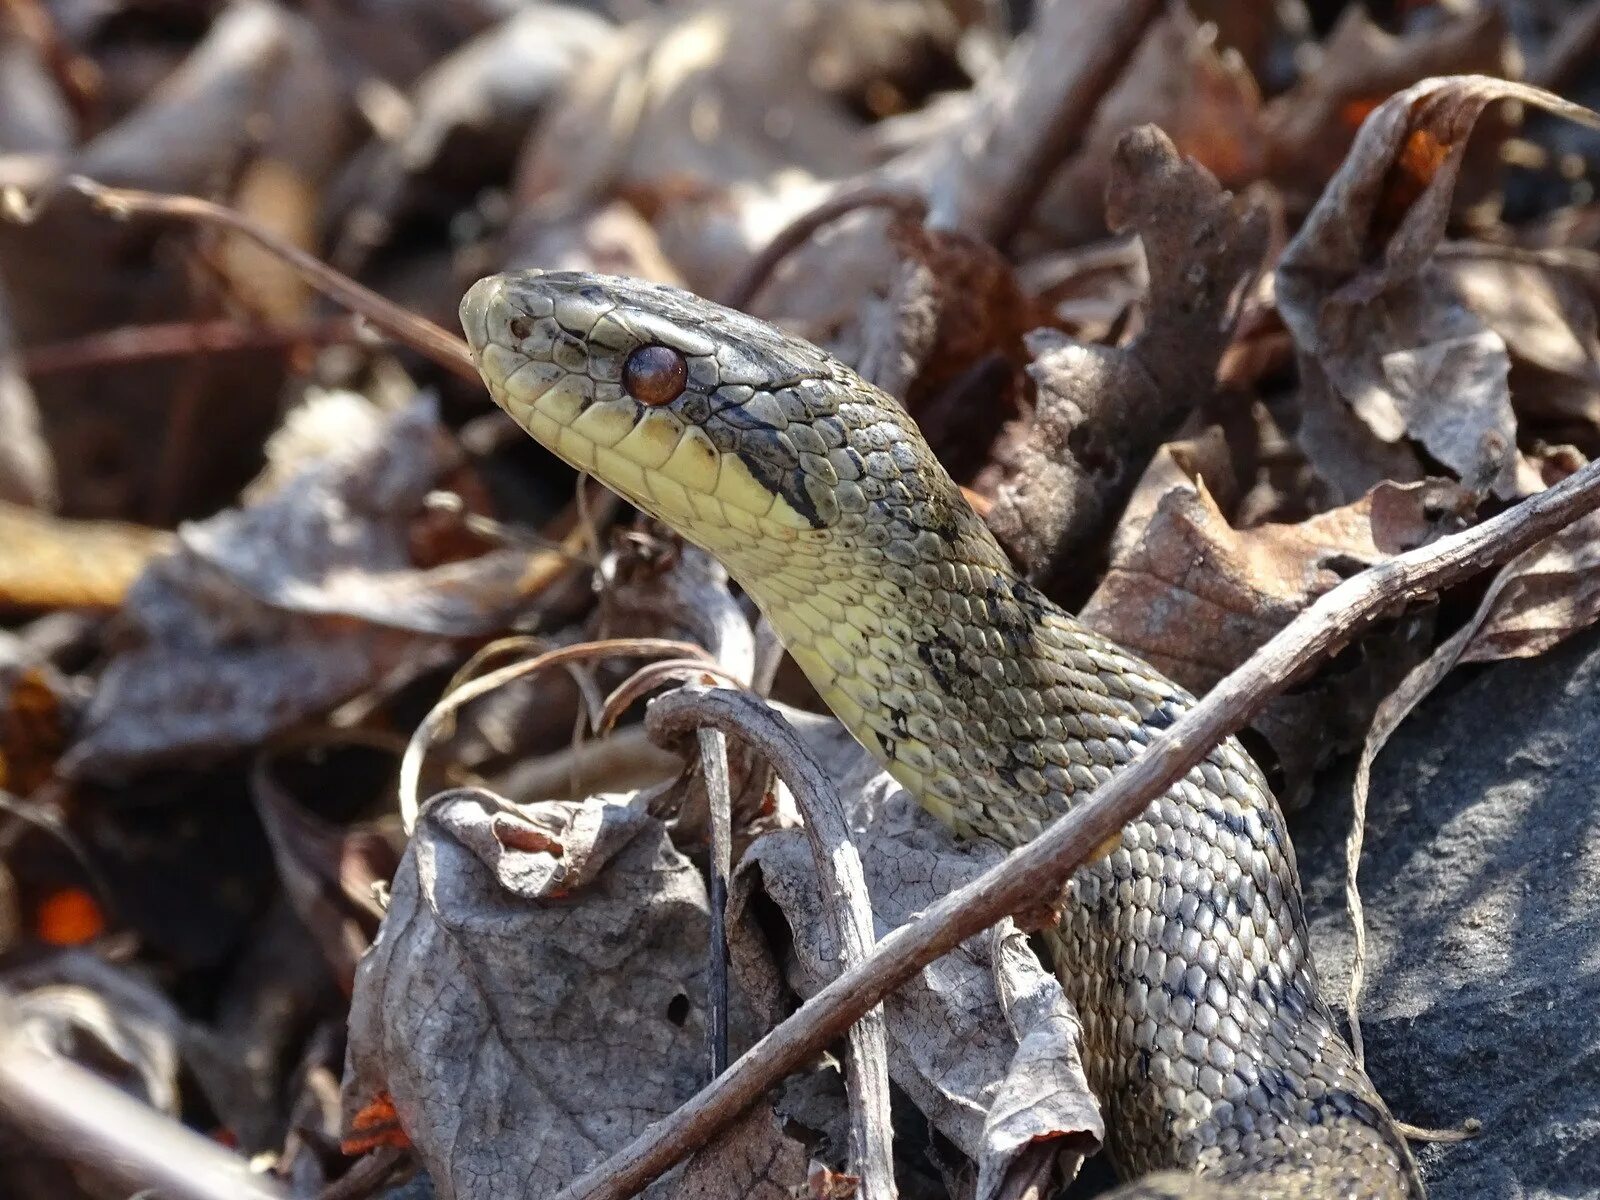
left=1294, top=632, right=1600, bottom=1200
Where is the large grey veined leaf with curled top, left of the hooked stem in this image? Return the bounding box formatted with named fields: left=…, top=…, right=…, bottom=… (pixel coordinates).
left=344, top=790, right=720, bottom=1200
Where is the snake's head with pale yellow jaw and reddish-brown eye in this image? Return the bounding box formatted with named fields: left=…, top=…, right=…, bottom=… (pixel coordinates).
left=461, top=270, right=864, bottom=549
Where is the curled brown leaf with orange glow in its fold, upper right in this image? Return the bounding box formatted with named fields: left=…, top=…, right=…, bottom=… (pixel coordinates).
left=1277, top=75, right=1595, bottom=499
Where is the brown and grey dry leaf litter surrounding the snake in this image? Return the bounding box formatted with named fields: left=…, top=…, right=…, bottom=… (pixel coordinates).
left=0, top=0, right=1600, bottom=1200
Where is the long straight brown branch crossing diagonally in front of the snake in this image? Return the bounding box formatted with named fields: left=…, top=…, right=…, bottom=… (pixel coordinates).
left=555, top=462, right=1600, bottom=1200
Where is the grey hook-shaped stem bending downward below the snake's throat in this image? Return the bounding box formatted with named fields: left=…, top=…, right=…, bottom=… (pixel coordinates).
left=645, top=686, right=894, bottom=1200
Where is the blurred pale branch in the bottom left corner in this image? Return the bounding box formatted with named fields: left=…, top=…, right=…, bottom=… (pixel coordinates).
left=0, top=1035, right=290, bottom=1200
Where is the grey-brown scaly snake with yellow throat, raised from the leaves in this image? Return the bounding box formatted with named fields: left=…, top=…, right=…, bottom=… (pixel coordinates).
left=461, top=270, right=1424, bottom=1200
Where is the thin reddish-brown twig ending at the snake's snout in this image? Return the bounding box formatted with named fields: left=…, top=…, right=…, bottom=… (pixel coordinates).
left=51, top=176, right=478, bottom=382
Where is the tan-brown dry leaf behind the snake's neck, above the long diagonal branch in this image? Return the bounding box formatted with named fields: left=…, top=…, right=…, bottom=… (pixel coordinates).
left=1080, top=446, right=1458, bottom=806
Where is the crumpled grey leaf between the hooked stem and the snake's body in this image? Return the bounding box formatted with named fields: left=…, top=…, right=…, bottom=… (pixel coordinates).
left=730, top=722, right=1104, bottom=1200
